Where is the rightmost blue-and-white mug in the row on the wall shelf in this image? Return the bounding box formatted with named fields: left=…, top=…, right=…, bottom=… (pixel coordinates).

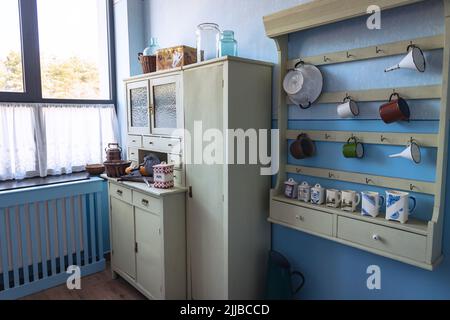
left=386, top=190, right=417, bottom=223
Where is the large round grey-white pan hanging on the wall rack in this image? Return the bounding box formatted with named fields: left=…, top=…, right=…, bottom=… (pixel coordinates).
left=283, top=61, right=323, bottom=109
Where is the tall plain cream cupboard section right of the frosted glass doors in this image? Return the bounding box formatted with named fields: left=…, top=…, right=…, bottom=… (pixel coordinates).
left=183, top=59, right=272, bottom=299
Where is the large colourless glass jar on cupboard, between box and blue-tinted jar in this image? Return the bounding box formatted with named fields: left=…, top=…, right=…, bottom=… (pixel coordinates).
left=196, top=23, right=220, bottom=62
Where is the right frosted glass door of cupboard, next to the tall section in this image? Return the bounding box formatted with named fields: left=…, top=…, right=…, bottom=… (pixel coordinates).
left=150, top=76, right=183, bottom=135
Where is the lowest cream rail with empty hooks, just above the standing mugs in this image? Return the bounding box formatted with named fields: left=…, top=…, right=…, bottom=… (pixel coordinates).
left=286, top=165, right=435, bottom=195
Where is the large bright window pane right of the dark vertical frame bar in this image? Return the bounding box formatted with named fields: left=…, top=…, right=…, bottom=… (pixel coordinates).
left=37, top=0, right=110, bottom=100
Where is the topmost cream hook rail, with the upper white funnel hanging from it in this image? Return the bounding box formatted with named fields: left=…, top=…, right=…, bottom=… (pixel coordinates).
left=287, top=35, right=444, bottom=69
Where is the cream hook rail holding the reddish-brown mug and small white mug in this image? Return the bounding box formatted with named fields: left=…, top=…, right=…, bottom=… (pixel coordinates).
left=286, top=85, right=442, bottom=104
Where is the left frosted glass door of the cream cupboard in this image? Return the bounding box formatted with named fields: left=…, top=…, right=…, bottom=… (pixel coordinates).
left=127, top=80, right=150, bottom=134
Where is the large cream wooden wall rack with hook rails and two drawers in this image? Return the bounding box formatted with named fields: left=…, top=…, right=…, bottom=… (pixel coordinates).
left=264, top=0, right=450, bottom=270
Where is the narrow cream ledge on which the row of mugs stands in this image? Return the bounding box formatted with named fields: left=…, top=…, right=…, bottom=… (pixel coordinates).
left=272, top=195, right=428, bottom=236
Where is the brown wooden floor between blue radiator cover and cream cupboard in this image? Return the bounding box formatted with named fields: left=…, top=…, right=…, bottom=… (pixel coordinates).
left=22, top=262, right=146, bottom=300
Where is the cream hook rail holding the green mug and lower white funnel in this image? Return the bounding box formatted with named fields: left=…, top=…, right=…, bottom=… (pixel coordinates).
left=286, top=130, right=438, bottom=147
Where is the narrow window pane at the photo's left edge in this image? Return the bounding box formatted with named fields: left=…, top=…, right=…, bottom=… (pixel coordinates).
left=0, top=0, right=24, bottom=92
